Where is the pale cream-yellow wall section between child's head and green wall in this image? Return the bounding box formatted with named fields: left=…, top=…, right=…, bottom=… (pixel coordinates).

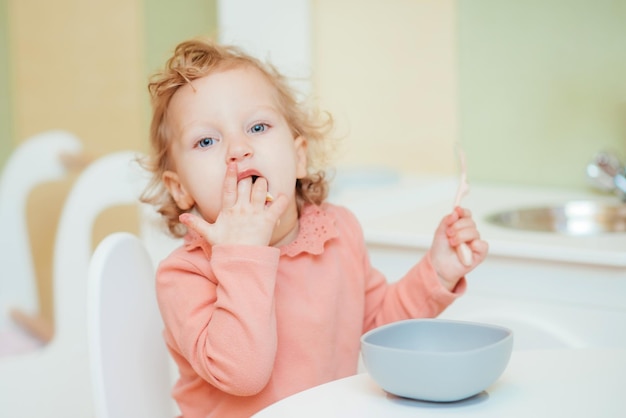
left=313, top=0, right=458, bottom=173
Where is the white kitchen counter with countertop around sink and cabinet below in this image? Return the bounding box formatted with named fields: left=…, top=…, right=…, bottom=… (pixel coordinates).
left=338, top=175, right=626, bottom=349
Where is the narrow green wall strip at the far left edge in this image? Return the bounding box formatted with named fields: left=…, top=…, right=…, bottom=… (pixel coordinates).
left=0, top=0, right=14, bottom=170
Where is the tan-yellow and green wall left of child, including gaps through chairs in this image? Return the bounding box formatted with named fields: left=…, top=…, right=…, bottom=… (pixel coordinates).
left=0, top=0, right=215, bottom=326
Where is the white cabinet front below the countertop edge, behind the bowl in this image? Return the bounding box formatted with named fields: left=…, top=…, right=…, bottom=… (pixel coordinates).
left=370, top=244, right=626, bottom=350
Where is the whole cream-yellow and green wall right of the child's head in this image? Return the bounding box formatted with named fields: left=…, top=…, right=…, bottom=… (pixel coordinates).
left=313, top=0, right=626, bottom=188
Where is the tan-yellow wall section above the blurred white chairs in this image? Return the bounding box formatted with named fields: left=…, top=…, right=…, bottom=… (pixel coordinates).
left=9, top=0, right=145, bottom=155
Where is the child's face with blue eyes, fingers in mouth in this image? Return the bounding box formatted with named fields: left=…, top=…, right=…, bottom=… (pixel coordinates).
left=163, top=67, right=307, bottom=222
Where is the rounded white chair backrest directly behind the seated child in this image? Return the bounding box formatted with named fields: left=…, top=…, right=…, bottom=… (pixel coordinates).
left=87, top=232, right=174, bottom=418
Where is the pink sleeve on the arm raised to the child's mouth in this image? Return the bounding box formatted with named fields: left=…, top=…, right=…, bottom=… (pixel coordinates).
left=157, top=246, right=279, bottom=396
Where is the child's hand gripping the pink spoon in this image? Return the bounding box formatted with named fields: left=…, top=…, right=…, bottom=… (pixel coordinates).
left=431, top=207, right=489, bottom=290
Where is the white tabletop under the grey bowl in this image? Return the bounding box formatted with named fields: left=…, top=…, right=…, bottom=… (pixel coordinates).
left=255, top=349, right=626, bottom=418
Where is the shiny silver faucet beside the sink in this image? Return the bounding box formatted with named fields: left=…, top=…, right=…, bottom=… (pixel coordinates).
left=587, top=152, right=626, bottom=202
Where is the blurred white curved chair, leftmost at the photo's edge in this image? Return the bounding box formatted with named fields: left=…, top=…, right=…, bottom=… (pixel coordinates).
left=0, top=131, right=82, bottom=356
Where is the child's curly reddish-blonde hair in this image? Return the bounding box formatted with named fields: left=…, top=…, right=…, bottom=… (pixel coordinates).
left=140, top=39, right=333, bottom=237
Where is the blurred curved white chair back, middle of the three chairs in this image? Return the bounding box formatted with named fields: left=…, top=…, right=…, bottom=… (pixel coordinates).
left=52, top=151, right=146, bottom=340
